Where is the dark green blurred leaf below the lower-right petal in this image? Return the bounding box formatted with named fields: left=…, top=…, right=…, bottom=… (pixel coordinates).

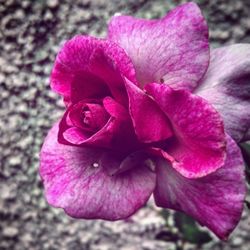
left=174, top=212, right=212, bottom=245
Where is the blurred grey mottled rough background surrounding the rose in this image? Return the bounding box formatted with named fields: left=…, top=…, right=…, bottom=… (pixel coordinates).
left=0, top=0, right=250, bottom=250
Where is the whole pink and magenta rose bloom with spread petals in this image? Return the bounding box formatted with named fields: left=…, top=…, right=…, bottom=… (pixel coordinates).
left=40, top=3, right=250, bottom=239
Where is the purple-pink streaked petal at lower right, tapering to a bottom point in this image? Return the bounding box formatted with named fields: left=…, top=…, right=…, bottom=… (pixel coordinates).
left=154, top=137, right=246, bottom=239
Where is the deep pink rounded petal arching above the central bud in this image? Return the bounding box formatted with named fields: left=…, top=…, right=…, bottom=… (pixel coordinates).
left=51, top=35, right=136, bottom=103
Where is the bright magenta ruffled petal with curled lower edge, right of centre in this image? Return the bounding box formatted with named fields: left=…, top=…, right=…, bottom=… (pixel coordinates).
left=145, top=83, right=226, bottom=178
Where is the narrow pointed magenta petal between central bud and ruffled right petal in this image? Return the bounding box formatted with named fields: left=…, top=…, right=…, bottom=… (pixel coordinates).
left=126, top=77, right=173, bottom=143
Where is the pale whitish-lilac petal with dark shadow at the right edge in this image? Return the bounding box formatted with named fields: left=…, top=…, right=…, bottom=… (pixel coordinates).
left=196, top=44, right=250, bottom=142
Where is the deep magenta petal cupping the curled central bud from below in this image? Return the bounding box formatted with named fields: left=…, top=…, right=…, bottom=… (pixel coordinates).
left=58, top=97, right=139, bottom=153
